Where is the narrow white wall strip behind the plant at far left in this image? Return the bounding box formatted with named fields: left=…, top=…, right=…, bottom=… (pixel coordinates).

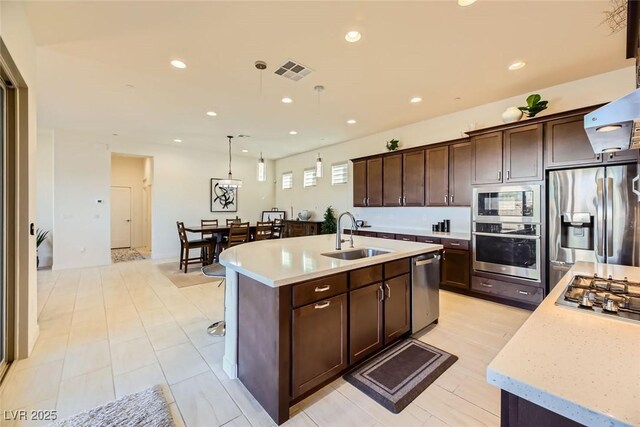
left=36, top=129, right=55, bottom=267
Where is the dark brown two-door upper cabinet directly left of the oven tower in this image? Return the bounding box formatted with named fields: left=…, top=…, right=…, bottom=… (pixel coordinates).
left=426, top=141, right=471, bottom=206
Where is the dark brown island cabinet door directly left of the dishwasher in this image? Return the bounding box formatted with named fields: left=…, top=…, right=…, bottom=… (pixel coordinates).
left=384, top=274, right=411, bottom=345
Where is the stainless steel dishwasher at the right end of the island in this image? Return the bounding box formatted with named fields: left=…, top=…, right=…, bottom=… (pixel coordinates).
left=411, top=252, right=441, bottom=334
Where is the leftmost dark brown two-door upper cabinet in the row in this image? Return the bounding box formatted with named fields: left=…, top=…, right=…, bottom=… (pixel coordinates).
left=353, top=157, right=382, bottom=207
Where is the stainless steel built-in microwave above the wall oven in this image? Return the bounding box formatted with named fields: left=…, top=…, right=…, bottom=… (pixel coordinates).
left=472, top=184, right=541, bottom=224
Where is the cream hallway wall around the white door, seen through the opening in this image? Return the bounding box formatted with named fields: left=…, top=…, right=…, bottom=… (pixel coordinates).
left=111, top=154, right=147, bottom=248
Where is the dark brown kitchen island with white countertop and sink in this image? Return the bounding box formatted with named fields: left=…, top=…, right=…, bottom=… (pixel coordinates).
left=220, top=235, right=442, bottom=424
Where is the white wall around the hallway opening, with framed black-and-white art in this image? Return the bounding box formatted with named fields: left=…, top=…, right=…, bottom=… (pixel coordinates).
left=53, top=130, right=274, bottom=269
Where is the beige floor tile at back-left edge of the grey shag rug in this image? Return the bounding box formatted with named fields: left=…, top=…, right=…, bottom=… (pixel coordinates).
left=57, top=367, right=115, bottom=418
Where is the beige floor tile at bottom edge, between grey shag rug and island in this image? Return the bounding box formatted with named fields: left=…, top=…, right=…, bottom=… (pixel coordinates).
left=171, top=372, right=241, bottom=427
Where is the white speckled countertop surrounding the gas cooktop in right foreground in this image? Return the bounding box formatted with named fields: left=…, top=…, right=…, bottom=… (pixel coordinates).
left=487, top=262, right=640, bottom=426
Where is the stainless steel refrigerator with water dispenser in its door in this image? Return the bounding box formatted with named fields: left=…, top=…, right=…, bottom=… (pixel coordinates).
left=548, top=164, right=640, bottom=290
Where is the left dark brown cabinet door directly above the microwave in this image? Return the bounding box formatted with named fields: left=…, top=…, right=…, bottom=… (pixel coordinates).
left=471, top=132, right=502, bottom=184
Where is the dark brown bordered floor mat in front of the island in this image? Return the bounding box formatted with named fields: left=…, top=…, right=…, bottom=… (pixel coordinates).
left=344, top=338, right=458, bottom=414
